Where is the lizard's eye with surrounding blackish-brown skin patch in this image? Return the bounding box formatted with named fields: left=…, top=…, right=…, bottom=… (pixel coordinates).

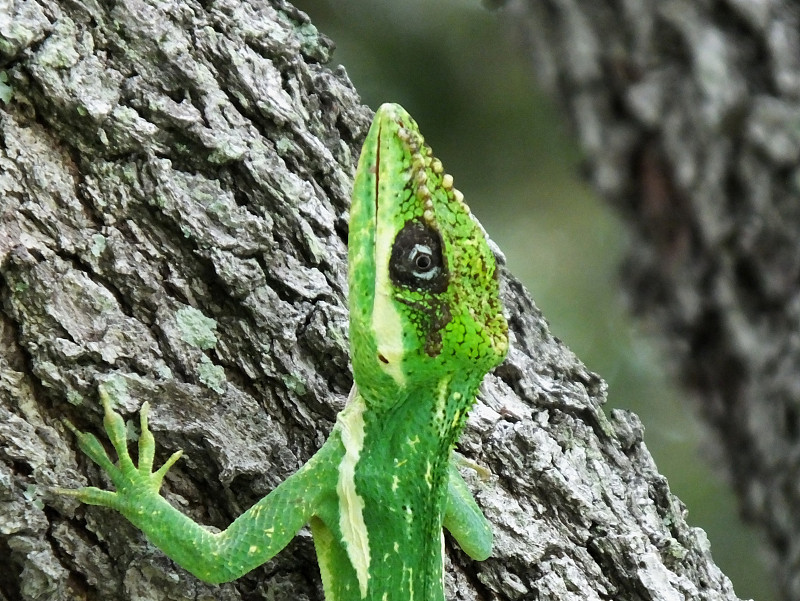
left=389, top=221, right=447, bottom=292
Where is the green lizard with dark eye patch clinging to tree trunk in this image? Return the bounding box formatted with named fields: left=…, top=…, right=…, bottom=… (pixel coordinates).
left=62, top=104, right=508, bottom=601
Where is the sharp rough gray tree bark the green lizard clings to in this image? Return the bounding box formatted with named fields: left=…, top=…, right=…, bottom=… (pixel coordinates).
left=0, top=0, right=736, bottom=601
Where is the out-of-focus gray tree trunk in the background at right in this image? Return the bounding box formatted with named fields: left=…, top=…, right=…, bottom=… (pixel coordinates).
left=496, top=0, right=800, bottom=599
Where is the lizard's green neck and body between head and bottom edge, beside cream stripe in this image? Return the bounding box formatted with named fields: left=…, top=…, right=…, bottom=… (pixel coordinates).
left=344, top=374, right=480, bottom=601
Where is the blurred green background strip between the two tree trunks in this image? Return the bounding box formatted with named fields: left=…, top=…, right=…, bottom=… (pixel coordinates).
left=294, top=0, right=777, bottom=601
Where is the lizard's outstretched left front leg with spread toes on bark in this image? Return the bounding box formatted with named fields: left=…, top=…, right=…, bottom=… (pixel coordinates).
left=57, top=387, right=336, bottom=583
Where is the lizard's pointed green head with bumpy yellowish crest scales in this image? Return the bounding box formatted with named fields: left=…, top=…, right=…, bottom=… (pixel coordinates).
left=348, top=104, right=508, bottom=405
